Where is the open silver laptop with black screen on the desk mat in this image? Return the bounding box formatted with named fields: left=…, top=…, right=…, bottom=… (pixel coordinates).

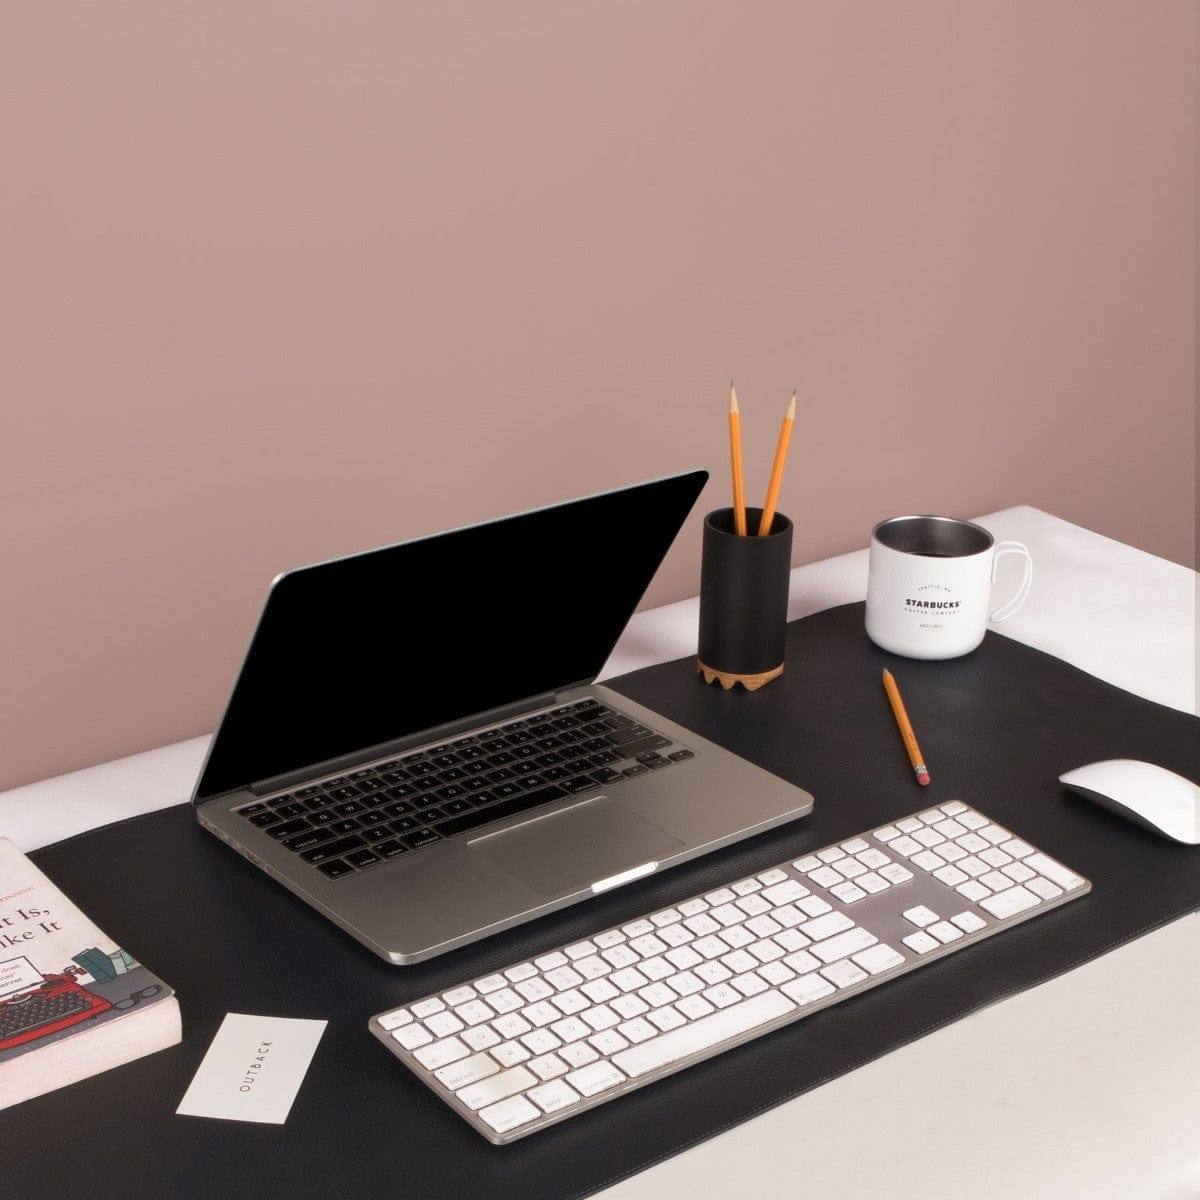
left=193, top=470, right=812, bottom=965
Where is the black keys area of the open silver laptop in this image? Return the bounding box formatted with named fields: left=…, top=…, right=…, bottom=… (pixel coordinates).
left=238, top=700, right=694, bottom=880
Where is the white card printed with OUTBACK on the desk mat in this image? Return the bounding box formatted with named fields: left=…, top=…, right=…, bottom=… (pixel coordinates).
left=175, top=1013, right=329, bottom=1124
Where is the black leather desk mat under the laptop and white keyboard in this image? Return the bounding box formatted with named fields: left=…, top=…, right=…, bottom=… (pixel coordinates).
left=11, top=605, right=1200, bottom=1200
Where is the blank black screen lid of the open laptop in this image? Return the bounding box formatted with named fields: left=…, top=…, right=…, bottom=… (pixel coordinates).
left=196, top=470, right=708, bottom=800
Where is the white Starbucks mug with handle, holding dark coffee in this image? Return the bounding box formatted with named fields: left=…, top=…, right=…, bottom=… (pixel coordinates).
left=866, top=516, right=1033, bottom=659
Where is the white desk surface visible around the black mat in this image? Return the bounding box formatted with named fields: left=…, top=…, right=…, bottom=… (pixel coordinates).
left=0, top=506, right=1200, bottom=1200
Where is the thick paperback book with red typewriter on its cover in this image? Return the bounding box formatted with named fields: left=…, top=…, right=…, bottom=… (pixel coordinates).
left=0, top=838, right=181, bottom=1109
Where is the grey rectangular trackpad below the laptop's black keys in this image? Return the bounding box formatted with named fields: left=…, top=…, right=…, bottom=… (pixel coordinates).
left=470, top=796, right=683, bottom=896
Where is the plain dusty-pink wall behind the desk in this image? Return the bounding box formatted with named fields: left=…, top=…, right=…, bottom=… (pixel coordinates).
left=0, top=0, right=1195, bottom=786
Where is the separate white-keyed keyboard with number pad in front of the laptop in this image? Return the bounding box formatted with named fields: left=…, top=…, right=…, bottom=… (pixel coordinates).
left=370, top=800, right=1091, bottom=1145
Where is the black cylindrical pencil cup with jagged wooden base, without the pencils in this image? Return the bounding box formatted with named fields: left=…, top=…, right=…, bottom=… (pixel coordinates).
left=697, top=509, right=792, bottom=691
